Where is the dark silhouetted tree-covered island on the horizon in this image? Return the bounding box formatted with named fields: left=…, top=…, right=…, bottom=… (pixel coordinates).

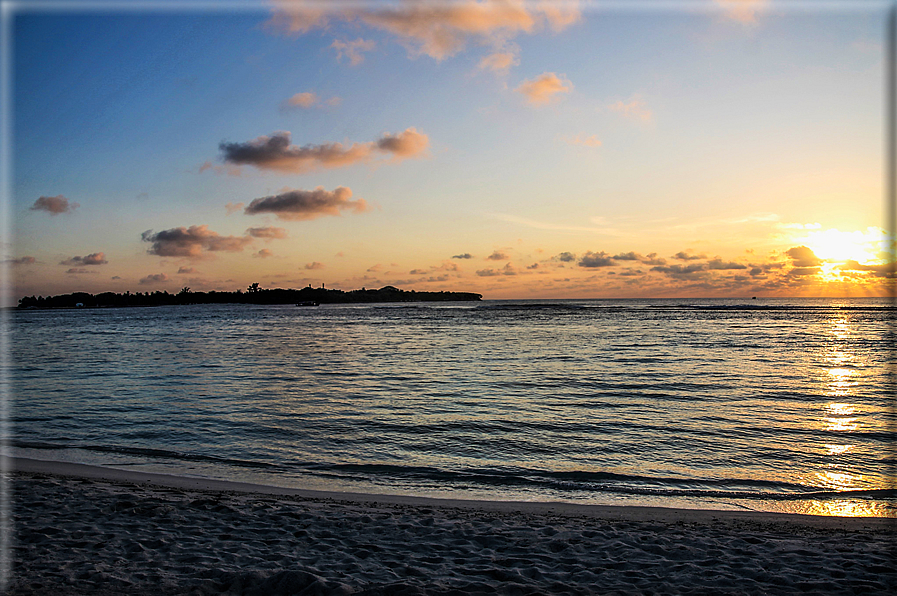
left=19, top=283, right=483, bottom=308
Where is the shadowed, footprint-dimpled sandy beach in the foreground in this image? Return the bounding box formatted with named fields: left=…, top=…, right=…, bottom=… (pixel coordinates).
left=4, top=459, right=897, bottom=596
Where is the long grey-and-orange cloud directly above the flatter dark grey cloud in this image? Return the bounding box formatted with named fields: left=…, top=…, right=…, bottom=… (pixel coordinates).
left=219, top=128, right=430, bottom=174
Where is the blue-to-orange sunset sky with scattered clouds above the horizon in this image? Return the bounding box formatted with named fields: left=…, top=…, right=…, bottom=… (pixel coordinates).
left=0, top=0, right=895, bottom=304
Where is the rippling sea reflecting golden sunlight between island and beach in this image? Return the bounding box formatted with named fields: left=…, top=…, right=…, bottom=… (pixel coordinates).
left=8, top=299, right=897, bottom=516
